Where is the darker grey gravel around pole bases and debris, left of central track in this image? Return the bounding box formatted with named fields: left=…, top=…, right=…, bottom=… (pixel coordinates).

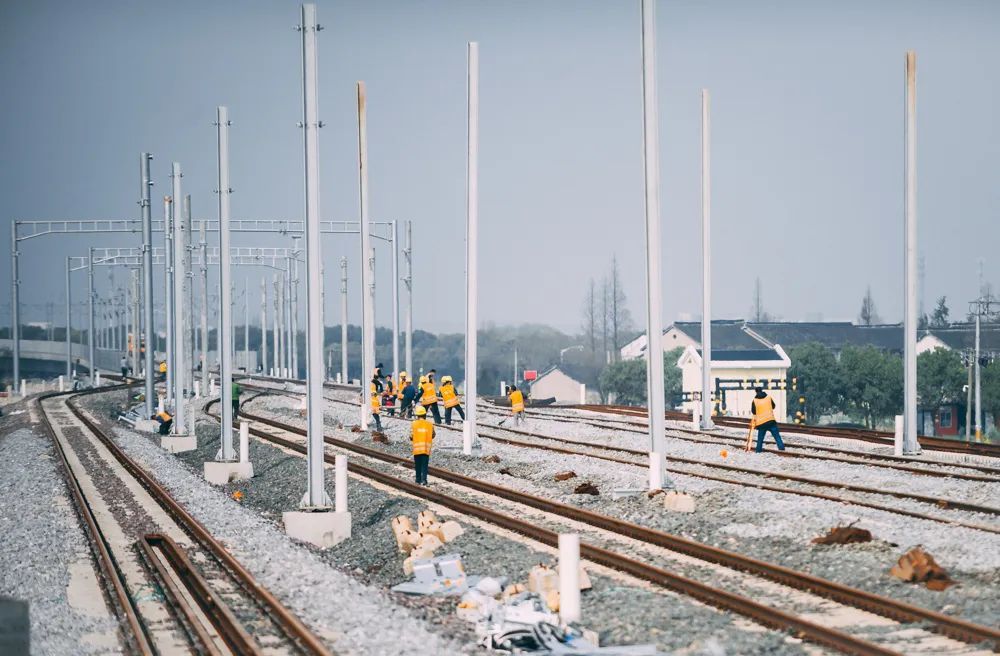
left=95, top=390, right=817, bottom=654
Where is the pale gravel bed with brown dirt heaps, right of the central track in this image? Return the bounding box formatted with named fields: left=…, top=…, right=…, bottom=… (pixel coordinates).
left=244, top=396, right=1000, bottom=626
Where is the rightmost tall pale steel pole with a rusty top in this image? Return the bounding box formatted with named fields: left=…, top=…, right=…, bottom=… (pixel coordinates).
left=903, top=50, right=920, bottom=455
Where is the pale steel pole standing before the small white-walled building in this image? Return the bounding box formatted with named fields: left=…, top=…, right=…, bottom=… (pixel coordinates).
left=701, top=89, right=715, bottom=430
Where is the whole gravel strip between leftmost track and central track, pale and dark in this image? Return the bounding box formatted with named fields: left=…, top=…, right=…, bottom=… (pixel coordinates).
left=78, top=395, right=816, bottom=654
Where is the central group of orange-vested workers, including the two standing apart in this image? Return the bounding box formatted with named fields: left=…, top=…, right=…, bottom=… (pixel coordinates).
left=368, top=363, right=525, bottom=485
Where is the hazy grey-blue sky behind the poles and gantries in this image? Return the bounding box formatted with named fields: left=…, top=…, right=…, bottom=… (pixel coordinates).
left=0, top=0, right=1000, bottom=330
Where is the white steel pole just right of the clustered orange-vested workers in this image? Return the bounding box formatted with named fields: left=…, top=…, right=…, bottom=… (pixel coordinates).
left=462, top=41, right=479, bottom=455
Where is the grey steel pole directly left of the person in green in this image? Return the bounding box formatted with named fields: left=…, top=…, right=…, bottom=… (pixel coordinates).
left=215, top=105, right=236, bottom=462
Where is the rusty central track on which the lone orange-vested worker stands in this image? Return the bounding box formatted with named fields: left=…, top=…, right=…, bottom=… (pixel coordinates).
left=225, top=390, right=1000, bottom=653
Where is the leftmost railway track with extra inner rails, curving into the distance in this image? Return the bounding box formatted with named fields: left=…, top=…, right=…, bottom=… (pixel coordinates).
left=36, top=385, right=330, bottom=656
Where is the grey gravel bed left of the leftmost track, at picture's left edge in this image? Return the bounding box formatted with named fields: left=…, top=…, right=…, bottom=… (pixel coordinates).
left=0, top=422, right=121, bottom=656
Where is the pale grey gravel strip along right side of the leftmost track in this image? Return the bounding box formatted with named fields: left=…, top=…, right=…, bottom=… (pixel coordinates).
left=83, top=393, right=466, bottom=655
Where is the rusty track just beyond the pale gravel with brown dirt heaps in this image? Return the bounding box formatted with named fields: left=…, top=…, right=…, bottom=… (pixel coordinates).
left=244, top=385, right=1000, bottom=534
